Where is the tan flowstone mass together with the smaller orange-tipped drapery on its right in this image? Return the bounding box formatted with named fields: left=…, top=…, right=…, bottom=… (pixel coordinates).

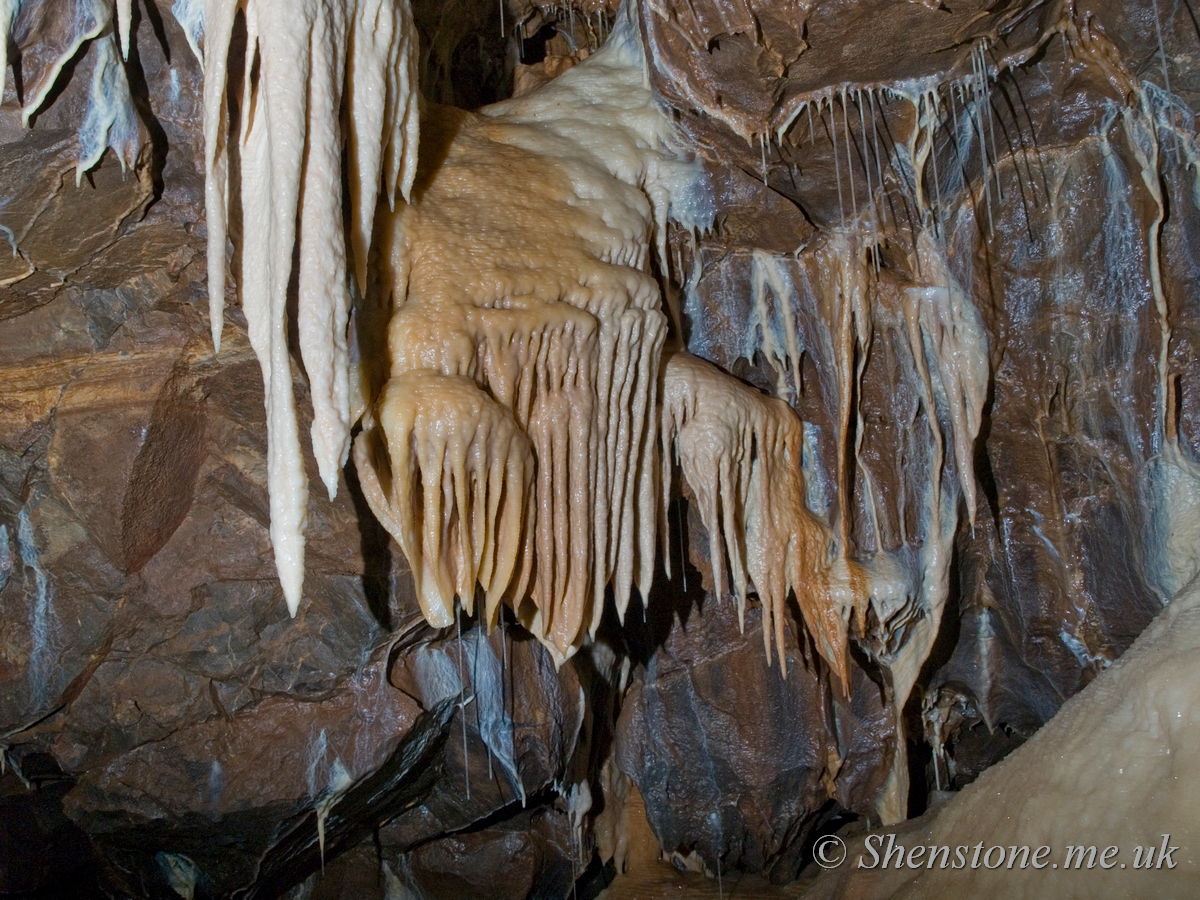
left=355, top=22, right=846, bottom=678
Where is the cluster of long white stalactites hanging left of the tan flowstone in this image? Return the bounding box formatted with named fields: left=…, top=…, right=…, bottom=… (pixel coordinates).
left=199, top=0, right=418, bottom=614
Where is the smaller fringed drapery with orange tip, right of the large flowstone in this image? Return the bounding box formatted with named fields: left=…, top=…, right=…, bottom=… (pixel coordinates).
left=662, top=353, right=862, bottom=684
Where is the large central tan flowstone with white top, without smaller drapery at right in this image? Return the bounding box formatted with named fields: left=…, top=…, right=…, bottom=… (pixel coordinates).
left=356, top=10, right=696, bottom=659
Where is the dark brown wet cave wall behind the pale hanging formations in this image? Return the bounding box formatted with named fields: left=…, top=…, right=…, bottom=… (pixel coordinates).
left=0, top=0, right=1200, bottom=900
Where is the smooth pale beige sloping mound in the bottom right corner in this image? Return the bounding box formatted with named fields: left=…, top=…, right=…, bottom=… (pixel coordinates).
left=805, top=583, right=1200, bottom=900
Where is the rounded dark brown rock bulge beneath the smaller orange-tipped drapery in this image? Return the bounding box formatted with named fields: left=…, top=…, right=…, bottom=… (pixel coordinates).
left=616, top=592, right=895, bottom=881
